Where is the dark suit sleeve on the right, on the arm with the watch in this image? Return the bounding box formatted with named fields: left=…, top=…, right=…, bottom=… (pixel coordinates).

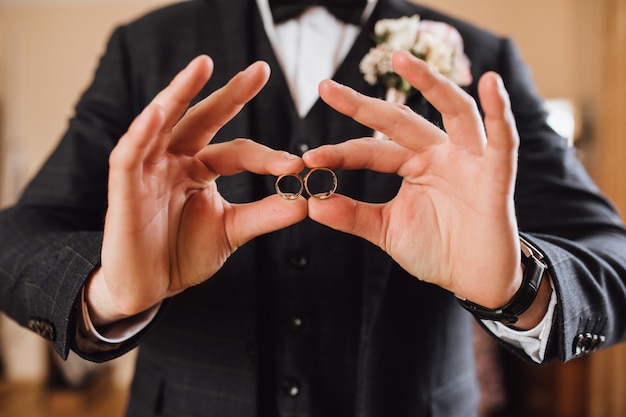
left=478, top=39, right=626, bottom=361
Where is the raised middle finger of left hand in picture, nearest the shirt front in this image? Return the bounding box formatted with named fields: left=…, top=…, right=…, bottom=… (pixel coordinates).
left=170, top=61, right=270, bottom=155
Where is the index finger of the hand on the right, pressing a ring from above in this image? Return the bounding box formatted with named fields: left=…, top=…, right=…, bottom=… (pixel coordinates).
left=302, top=138, right=411, bottom=173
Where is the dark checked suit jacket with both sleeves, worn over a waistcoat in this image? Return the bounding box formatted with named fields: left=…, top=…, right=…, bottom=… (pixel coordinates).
left=0, top=0, right=626, bottom=417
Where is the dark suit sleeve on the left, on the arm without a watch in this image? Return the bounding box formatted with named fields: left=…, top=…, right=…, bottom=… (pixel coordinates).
left=0, top=29, right=154, bottom=361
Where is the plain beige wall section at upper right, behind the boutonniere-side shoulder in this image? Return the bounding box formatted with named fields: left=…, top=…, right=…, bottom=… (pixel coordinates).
left=422, top=0, right=601, bottom=105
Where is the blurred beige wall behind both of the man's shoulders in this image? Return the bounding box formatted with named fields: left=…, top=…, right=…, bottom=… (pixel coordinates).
left=0, top=0, right=601, bottom=205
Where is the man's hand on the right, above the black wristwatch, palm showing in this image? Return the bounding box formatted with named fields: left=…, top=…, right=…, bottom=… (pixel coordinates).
left=303, top=52, right=522, bottom=308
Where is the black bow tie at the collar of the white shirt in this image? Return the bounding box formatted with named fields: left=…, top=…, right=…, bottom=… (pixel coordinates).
left=269, top=0, right=367, bottom=25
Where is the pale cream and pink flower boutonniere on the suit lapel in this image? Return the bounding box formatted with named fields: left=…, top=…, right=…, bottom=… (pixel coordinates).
left=359, top=15, right=472, bottom=136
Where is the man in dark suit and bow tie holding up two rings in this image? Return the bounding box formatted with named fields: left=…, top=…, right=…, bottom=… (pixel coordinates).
left=0, top=0, right=626, bottom=416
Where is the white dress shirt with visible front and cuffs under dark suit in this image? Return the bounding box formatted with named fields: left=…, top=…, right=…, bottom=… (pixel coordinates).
left=81, top=0, right=557, bottom=363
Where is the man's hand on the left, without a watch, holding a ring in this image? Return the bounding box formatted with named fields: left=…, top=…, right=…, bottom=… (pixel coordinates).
left=87, top=56, right=307, bottom=325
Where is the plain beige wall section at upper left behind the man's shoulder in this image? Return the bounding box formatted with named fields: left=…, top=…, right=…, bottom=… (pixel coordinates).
left=0, top=0, right=176, bottom=205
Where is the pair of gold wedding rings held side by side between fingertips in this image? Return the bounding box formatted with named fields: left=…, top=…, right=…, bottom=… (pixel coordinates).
left=275, top=168, right=337, bottom=200
